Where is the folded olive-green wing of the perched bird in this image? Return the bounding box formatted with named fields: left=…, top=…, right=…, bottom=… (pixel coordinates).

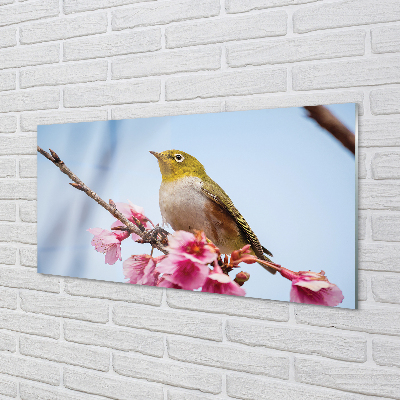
left=201, top=179, right=272, bottom=261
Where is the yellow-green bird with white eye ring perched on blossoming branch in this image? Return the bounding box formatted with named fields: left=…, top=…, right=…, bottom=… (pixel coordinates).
left=150, top=150, right=275, bottom=273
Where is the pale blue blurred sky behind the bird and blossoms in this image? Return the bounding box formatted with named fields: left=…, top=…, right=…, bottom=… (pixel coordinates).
left=38, top=104, right=356, bottom=308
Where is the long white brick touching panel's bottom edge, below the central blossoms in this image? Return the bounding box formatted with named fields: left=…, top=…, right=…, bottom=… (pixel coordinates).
left=167, top=290, right=289, bottom=321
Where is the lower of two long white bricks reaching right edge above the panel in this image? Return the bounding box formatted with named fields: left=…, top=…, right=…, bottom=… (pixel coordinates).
left=293, top=55, right=400, bottom=91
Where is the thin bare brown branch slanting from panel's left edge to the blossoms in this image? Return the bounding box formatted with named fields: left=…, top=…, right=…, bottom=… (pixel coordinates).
left=37, top=146, right=168, bottom=254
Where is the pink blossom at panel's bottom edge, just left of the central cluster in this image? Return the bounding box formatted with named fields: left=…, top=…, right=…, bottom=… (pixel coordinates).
left=123, top=254, right=165, bottom=286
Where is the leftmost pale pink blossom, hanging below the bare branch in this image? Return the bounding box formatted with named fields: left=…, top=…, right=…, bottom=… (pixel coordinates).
left=88, top=228, right=129, bottom=265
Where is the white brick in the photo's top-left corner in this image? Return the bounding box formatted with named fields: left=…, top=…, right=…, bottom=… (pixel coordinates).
left=0, top=0, right=59, bottom=26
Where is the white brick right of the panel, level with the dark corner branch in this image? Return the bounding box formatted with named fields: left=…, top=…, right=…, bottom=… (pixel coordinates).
left=358, top=117, right=400, bottom=147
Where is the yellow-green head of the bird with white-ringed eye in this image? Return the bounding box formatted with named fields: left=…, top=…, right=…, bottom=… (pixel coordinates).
left=150, top=150, right=206, bottom=181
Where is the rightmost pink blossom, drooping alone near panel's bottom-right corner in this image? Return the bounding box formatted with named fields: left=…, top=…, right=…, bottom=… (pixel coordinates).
left=279, top=268, right=344, bottom=307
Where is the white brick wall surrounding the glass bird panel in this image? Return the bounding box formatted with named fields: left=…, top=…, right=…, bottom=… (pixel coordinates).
left=0, top=0, right=400, bottom=400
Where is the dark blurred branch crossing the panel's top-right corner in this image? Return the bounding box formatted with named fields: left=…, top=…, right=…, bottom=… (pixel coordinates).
left=304, top=106, right=356, bottom=154
